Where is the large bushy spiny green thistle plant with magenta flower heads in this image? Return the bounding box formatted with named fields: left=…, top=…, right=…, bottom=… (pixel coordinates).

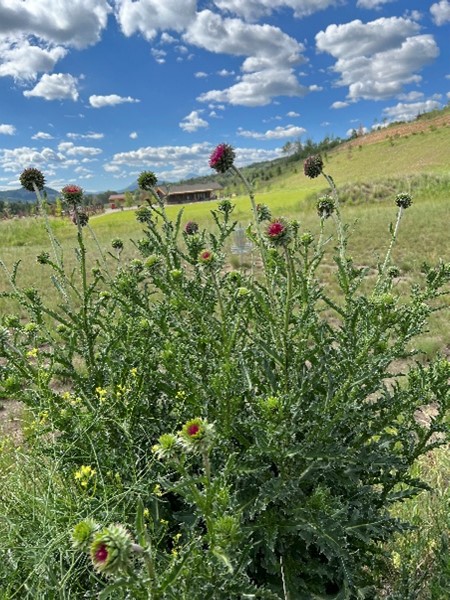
left=0, top=152, right=450, bottom=600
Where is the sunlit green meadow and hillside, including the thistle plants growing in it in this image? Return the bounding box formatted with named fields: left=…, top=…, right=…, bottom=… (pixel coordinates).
left=0, top=115, right=450, bottom=600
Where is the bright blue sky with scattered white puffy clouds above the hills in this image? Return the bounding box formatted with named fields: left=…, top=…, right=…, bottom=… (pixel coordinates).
left=0, top=0, right=450, bottom=191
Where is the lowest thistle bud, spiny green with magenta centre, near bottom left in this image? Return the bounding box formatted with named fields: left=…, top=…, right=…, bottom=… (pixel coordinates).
left=90, top=524, right=133, bottom=576
